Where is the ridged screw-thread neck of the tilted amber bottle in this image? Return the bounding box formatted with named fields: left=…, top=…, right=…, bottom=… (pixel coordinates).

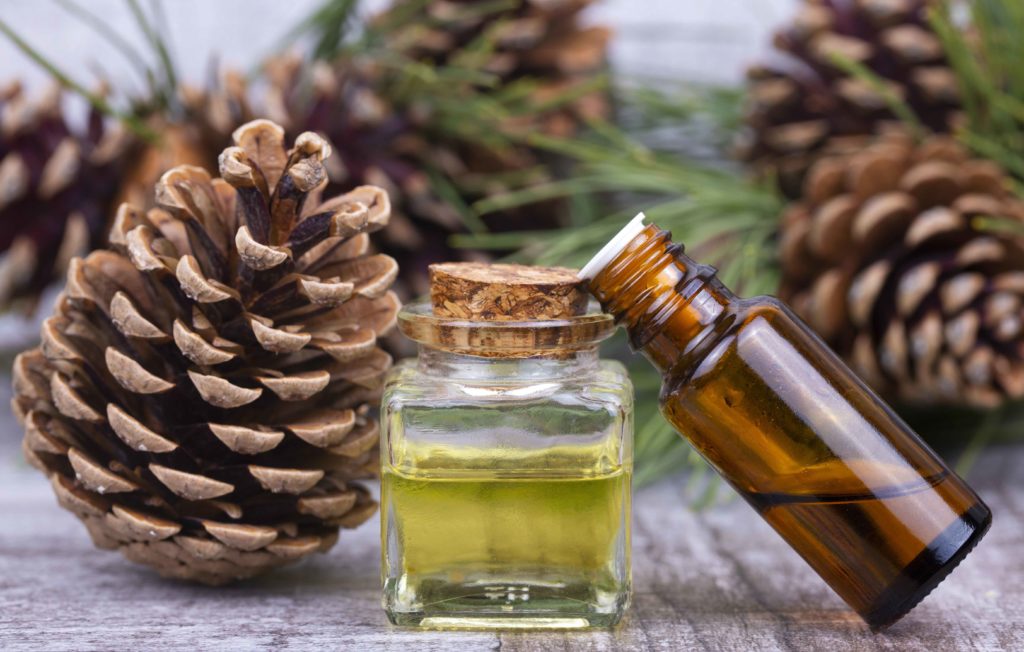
left=589, top=225, right=736, bottom=373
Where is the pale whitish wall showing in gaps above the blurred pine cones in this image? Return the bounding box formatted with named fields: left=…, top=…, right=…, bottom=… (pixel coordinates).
left=0, top=0, right=797, bottom=87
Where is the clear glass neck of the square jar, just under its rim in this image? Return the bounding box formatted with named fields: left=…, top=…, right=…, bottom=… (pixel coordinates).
left=418, top=344, right=599, bottom=382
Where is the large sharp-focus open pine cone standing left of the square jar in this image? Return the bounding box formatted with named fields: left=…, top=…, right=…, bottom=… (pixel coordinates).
left=14, top=121, right=398, bottom=583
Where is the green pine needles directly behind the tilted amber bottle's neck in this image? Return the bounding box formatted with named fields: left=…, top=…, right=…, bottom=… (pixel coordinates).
left=453, top=90, right=782, bottom=487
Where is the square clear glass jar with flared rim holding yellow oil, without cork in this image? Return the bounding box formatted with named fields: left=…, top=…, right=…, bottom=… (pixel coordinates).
left=381, top=303, right=633, bottom=628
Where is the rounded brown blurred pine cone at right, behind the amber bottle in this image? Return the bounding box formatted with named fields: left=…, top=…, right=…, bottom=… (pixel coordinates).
left=780, top=135, right=1024, bottom=406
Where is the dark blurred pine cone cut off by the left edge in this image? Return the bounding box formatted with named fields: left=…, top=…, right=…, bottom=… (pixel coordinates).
left=0, top=83, right=128, bottom=311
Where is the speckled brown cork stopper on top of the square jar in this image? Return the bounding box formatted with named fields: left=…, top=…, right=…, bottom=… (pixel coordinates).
left=430, top=263, right=588, bottom=321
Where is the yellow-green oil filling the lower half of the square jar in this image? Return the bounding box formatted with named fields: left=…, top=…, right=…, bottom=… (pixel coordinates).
left=381, top=454, right=631, bottom=626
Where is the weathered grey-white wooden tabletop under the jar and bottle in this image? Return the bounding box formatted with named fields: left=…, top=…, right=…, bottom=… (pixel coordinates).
left=0, top=378, right=1024, bottom=652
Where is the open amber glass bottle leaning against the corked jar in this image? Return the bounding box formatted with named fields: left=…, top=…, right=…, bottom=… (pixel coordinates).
left=581, top=215, right=991, bottom=629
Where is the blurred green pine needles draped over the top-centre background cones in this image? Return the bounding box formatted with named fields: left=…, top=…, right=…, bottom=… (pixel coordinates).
left=286, top=0, right=608, bottom=239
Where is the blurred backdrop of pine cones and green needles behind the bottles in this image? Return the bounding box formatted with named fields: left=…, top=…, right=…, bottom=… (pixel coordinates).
left=0, top=0, right=1024, bottom=505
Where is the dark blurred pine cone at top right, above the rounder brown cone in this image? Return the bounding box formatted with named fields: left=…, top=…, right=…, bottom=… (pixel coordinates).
left=740, top=0, right=959, bottom=198
